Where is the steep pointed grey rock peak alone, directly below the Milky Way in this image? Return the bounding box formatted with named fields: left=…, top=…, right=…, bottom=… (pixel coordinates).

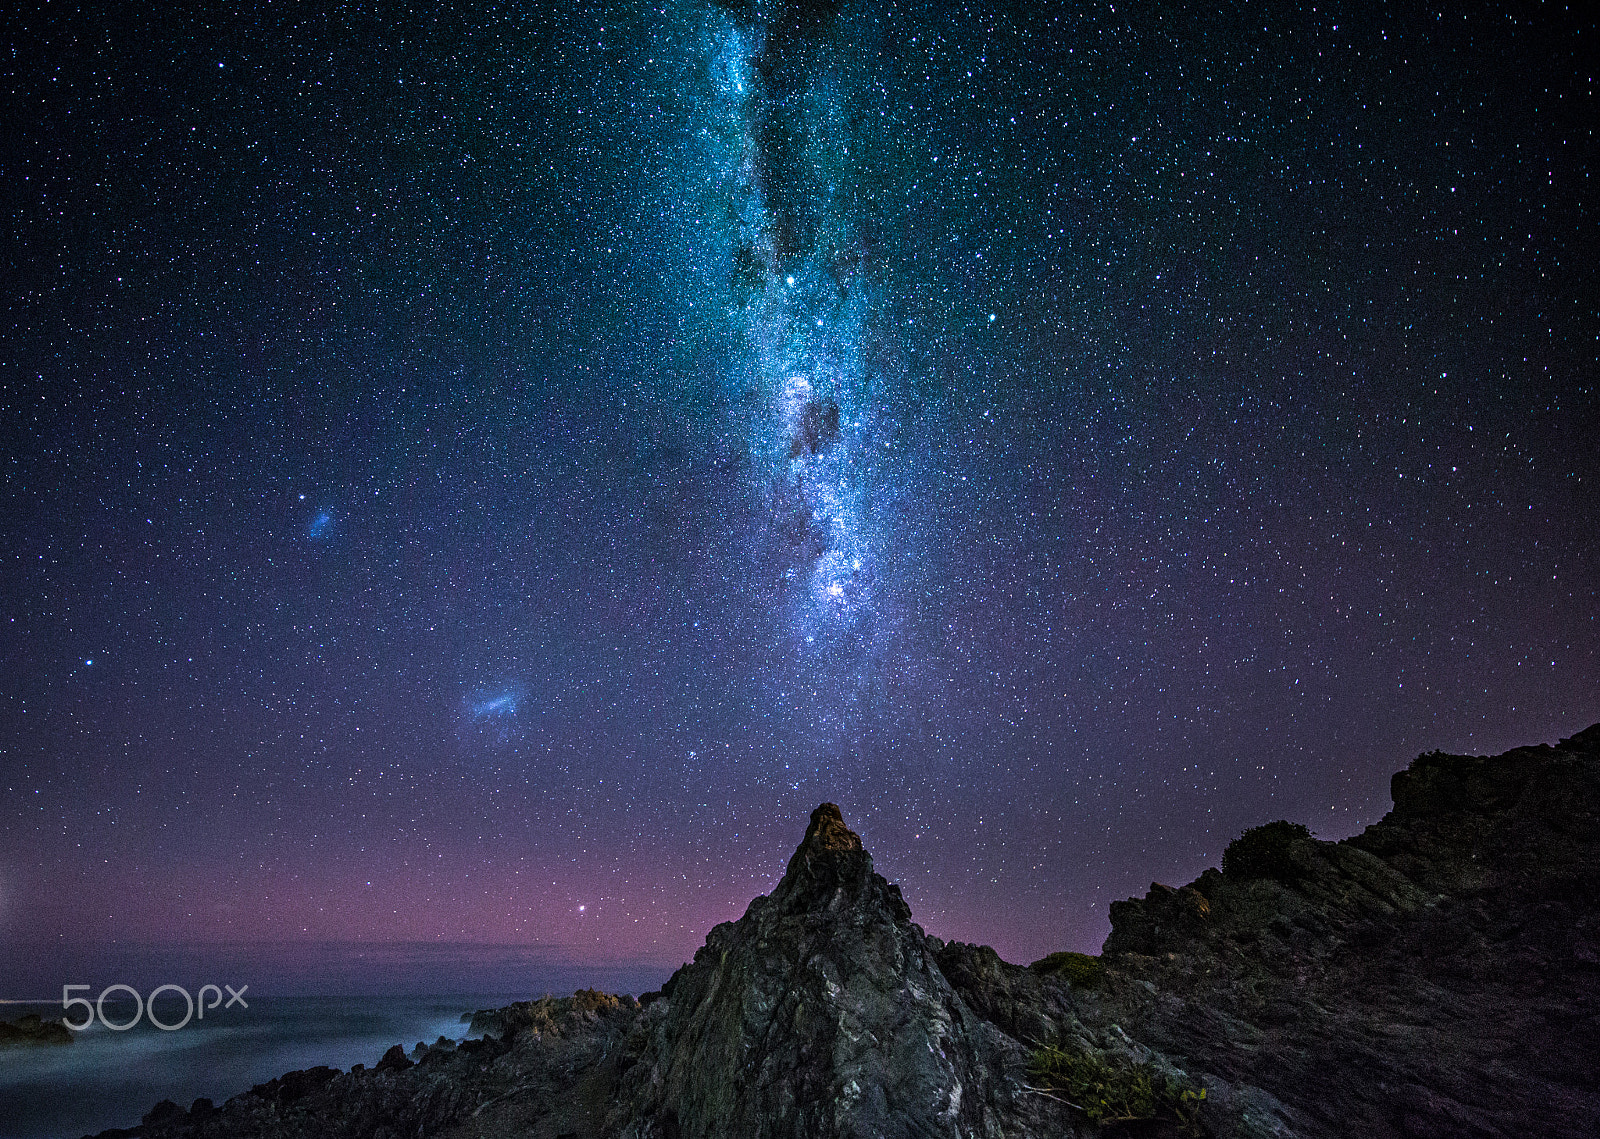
left=610, top=803, right=1067, bottom=1139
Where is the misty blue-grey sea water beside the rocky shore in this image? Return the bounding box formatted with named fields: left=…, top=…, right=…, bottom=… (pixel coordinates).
left=0, top=992, right=512, bottom=1139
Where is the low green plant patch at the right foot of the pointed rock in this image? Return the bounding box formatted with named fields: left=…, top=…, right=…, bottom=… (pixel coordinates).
left=1029, top=1045, right=1205, bottom=1136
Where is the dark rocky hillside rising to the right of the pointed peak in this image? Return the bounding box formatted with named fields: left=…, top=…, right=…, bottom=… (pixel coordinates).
left=1091, top=725, right=1600, bottom=1139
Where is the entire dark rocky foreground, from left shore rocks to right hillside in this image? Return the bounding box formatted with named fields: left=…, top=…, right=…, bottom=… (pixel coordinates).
left=106, top=725, right=1600, bottom=1139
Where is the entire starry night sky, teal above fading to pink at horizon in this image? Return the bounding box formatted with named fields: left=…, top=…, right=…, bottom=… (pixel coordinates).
left=0, top=0, right=1600, bottom=997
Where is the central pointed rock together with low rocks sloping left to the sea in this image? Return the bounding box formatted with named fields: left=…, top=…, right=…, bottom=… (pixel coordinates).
left=103, top=803, right=1136, bottom=1139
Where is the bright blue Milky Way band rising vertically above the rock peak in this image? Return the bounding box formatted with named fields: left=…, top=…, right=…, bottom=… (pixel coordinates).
left=710, top=3, right=885, bottom=684
